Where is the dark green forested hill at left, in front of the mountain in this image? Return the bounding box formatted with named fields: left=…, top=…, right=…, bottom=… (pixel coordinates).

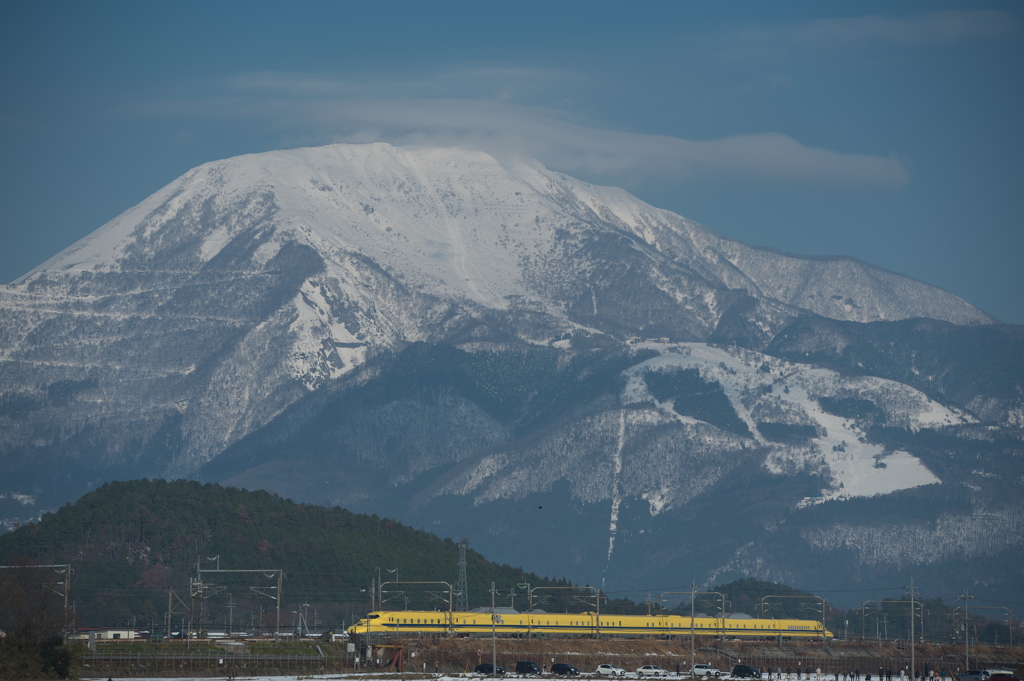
left=0, top=480, right=567, bottom=632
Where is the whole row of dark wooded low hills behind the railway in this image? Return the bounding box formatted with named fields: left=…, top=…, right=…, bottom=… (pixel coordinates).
left=0, top=480, right=1008, bottom=641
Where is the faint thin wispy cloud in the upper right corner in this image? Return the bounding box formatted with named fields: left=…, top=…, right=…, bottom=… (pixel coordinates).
left=738, top=10, right=1017, bottom=47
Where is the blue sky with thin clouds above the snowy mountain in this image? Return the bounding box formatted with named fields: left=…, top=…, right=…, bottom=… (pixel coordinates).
left=6, top=0, right=1024, bottom=324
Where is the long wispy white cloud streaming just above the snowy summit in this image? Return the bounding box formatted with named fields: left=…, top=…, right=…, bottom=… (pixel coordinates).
left=132, top=69, right=907, bottom=188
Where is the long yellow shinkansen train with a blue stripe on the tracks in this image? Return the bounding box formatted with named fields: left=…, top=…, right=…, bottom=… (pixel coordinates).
left=348, top=610, right=833, bottom=641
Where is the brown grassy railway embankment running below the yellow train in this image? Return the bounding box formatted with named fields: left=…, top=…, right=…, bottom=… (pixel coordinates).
left=83, top=638, right=1024, bottom=681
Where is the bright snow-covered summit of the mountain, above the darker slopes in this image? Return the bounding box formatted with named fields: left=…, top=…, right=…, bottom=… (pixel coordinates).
left=15, top=143, right=992, bottom=324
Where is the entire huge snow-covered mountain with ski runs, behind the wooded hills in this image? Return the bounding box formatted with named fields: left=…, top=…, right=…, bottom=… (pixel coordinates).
left=0, top=144, right=1024, bottom=606
